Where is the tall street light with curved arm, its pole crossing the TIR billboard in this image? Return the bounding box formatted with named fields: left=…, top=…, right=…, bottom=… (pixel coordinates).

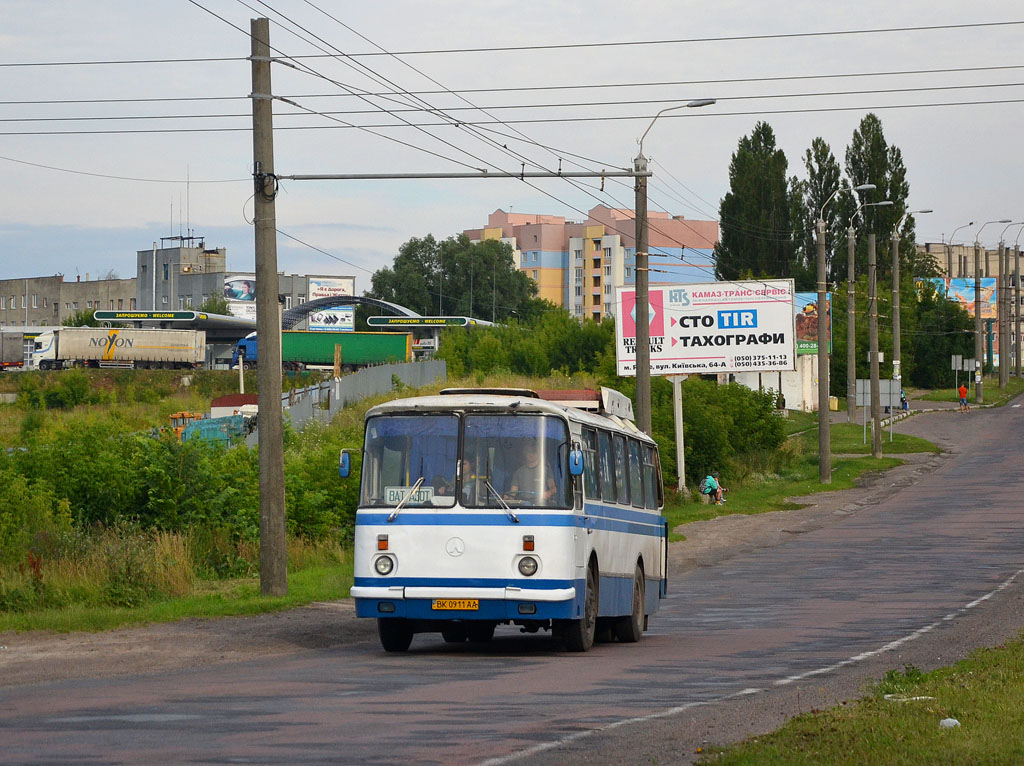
left=633, top=98, right=715, bottom=435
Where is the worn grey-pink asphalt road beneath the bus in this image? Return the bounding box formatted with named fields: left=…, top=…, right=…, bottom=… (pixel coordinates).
left=0, top=397, right=1024, bottom=766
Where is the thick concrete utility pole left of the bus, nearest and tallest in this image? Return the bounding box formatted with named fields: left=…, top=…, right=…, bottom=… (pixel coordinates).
left=250, top=18, right=288, bottom=596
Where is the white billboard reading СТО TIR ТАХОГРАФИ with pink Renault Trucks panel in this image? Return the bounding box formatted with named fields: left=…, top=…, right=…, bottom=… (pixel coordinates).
left=615, top=280, right=796, bottom=376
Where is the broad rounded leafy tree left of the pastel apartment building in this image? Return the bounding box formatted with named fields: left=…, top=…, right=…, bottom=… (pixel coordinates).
left=367, top=235, right=550, bottom=322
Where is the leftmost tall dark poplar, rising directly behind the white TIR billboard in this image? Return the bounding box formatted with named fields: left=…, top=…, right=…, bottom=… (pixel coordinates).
left=715, top=122, right=797, bottom=280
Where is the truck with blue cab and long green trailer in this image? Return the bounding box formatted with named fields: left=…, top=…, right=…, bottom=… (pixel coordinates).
left=231, top=330, right=413, bottom=373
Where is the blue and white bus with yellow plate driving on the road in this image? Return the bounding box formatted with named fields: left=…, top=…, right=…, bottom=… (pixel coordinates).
left=340, top=389, right=668, bottom=651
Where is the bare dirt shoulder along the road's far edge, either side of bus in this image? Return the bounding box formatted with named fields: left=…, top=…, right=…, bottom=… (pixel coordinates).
left=0, top=414, right=956, bottom=686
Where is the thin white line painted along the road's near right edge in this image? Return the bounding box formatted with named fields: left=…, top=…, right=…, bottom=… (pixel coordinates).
left=477, top=569, right=1024, bottom=766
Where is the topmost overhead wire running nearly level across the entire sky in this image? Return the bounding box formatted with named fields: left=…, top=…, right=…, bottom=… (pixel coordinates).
left=0, top=19, right=1024, bottom=68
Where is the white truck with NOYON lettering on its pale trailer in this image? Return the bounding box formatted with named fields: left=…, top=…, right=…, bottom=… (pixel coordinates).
left=32, top=327, right=206, bottom=370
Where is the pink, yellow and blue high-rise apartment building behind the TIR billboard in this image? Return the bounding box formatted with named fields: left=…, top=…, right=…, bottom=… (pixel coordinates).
left=465, top=205, right=718, bottom=321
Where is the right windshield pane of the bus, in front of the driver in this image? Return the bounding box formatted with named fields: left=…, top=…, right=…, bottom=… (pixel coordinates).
left=461, top=414, right=571, bottom=508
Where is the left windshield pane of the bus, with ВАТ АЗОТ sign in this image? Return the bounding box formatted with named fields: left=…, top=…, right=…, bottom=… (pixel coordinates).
left=361, top=414, right=459, bottom=508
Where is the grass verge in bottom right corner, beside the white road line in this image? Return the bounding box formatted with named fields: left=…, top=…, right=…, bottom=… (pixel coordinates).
left=701, top=638, right=1024, bottom=766
